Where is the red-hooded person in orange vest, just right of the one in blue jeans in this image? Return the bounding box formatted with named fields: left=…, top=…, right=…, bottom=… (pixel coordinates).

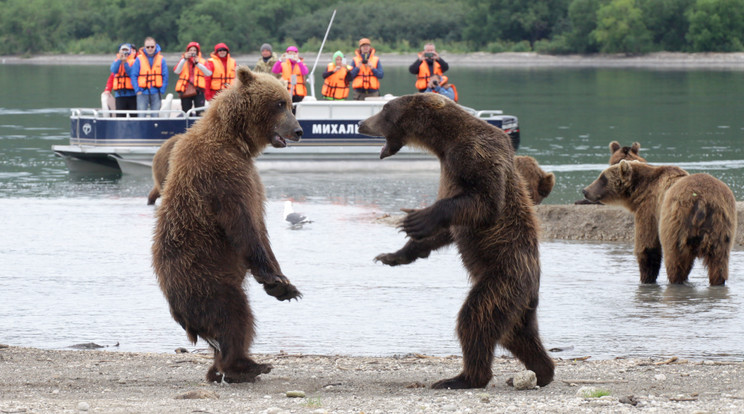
left=173, top=42, right=212, bottom=112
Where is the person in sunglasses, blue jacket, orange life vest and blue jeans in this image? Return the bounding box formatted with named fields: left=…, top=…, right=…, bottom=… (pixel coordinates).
left=130, top=37, right=168, bottom=116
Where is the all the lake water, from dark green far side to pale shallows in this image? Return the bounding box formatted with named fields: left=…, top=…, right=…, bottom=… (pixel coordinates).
left=0, top=66, right=744, bottom=360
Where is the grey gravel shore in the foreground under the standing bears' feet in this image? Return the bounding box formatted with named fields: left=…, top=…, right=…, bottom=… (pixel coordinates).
left=0, top=346, right=744, bottom=414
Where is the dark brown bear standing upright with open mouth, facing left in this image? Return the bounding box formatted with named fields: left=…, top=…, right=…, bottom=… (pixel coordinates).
left=359, top=93, right=554, bottom=389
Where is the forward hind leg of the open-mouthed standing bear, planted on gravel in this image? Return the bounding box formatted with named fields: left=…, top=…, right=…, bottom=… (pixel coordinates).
left=431, top=282, right=508, bottom=389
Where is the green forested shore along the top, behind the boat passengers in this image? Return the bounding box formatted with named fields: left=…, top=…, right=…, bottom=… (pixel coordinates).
left=0, top=0, right=744, bottom=57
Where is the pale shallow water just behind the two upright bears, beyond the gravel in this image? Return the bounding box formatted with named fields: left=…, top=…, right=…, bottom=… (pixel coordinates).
left=0, top=196, right=744, bottom=359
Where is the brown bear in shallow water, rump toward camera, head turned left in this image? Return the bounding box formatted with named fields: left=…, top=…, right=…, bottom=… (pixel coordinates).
left=584, top=161, right=736, bottom=285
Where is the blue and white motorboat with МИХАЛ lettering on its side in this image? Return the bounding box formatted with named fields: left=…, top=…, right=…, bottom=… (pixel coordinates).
left=52, top=94, right=520, bottom=175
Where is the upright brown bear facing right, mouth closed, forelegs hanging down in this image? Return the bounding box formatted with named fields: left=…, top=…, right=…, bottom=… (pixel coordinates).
left=152, top=67, right=302, bottom=382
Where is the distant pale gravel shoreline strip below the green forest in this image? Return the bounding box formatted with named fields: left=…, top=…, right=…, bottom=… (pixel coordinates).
left=0, top=51, right=744, bottom=70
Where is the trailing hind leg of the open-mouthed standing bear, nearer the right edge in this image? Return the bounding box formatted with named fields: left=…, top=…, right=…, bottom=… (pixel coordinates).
left=503, top=299, right=555, bottom=387
